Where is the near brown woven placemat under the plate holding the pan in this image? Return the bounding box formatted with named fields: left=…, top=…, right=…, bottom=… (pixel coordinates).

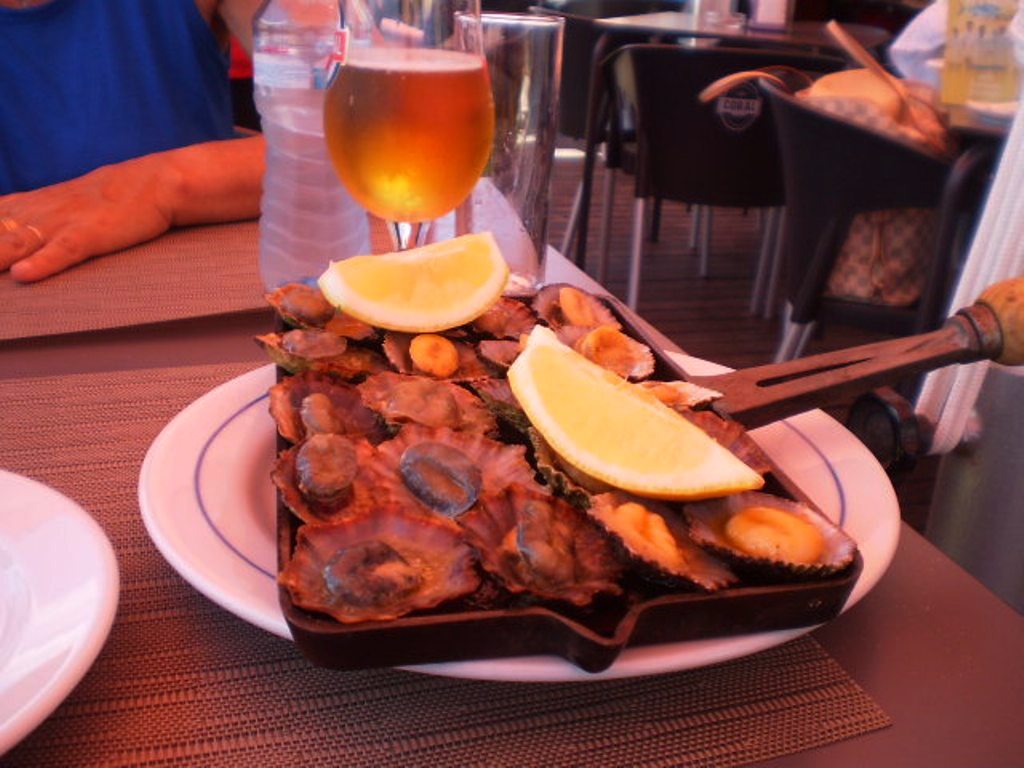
left=0, top=366, right=889, bottom=768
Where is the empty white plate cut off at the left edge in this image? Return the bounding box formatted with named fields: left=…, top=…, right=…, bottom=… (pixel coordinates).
left=0, top=470, right=118, bottom=755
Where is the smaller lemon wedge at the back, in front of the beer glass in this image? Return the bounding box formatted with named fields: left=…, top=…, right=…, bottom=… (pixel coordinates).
left=318, top=232, right=509, bottom=333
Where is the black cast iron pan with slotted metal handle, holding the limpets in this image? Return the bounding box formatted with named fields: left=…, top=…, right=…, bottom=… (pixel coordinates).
left=278, top=284, right=991, bottom=672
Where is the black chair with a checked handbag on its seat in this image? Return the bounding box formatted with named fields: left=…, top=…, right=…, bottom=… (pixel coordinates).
left=762, top=86, right=995, bottom=360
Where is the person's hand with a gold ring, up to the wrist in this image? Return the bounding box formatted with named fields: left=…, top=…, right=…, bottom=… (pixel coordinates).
left=0, top=156, right=173, bottom=283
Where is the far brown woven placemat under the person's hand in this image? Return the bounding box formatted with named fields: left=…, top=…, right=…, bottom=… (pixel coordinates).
left=0, top=221, right=265, bottom=340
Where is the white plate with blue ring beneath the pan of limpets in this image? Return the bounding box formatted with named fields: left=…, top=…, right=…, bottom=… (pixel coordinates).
left=139, top=357, right=900, bottom=681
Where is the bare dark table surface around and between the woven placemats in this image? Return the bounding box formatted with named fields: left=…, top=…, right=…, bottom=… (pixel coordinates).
left=0, top=249, right=1024, bottom=768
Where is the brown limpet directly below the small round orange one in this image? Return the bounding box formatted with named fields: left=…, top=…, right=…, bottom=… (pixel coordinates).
left=357, top=371, right=498, bottom=434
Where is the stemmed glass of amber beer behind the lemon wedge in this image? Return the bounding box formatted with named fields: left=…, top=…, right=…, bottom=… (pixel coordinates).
left=324, top=0, right=495, bottom=250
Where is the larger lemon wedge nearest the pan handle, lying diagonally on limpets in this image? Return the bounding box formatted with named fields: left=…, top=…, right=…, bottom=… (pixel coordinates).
left=508, top=326, right=764, bottom=501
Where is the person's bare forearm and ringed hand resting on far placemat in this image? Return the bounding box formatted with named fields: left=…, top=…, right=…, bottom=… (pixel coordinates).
left=0, top=136, right=263, bottom=282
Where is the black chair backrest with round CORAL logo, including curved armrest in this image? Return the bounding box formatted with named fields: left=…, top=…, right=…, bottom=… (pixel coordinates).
left=608, top=45, right=843, bottom=207
